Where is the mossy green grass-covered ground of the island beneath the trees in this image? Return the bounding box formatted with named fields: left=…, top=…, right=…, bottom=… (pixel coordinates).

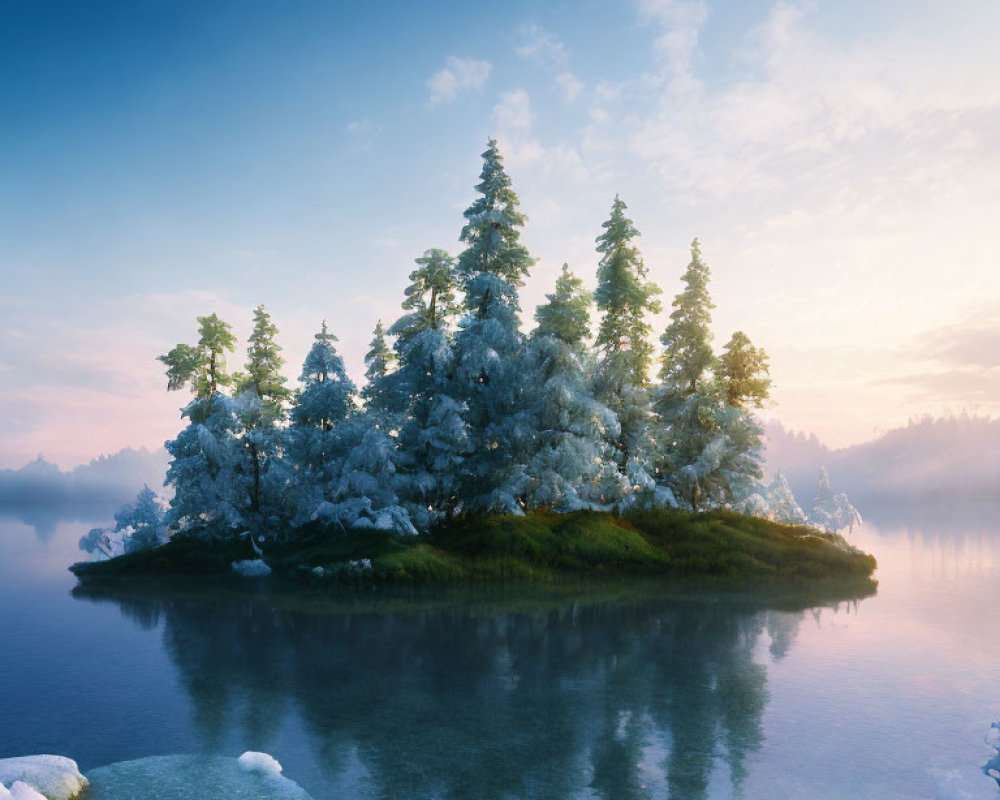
left=70, top=511, right=876, bottom=585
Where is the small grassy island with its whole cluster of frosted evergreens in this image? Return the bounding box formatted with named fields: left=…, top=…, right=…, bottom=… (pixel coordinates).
left=71, top=139, right=876, bottom=585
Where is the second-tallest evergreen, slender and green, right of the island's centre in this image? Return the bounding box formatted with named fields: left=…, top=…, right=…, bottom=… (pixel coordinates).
left=594, top=197, right=660, bottom=504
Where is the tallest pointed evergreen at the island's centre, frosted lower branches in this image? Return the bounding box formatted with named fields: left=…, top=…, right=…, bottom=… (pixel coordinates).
left=454, top=139, right=534, bottom=512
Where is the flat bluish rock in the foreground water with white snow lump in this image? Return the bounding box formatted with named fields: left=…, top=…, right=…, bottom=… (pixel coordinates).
left=88, top=753, right=312, bottom=800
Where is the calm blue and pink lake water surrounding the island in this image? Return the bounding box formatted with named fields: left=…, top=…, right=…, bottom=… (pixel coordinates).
left=0, top=508, right=1000, bottom=800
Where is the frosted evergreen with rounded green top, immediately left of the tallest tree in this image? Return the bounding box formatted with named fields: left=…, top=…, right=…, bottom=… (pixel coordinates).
left=391, top=250, right=468, bottom=529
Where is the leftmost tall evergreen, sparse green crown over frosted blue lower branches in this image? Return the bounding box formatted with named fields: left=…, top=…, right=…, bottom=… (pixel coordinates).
left=158, top=314, right=243, bottom=536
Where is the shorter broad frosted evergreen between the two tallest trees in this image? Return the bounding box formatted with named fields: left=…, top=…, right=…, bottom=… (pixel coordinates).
left=525, top=264, right=618, bottom=511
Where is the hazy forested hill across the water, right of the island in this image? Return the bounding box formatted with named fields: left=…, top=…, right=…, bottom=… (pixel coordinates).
left=765, top=414, right=1000, bottom=505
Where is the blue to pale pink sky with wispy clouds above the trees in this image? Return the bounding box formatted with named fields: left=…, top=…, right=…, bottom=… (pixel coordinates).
left=0, top=0, right=1000, bottom=468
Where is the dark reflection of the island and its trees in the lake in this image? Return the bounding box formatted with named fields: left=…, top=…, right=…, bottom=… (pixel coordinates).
left=74, top=587, right=876, bottom=800
